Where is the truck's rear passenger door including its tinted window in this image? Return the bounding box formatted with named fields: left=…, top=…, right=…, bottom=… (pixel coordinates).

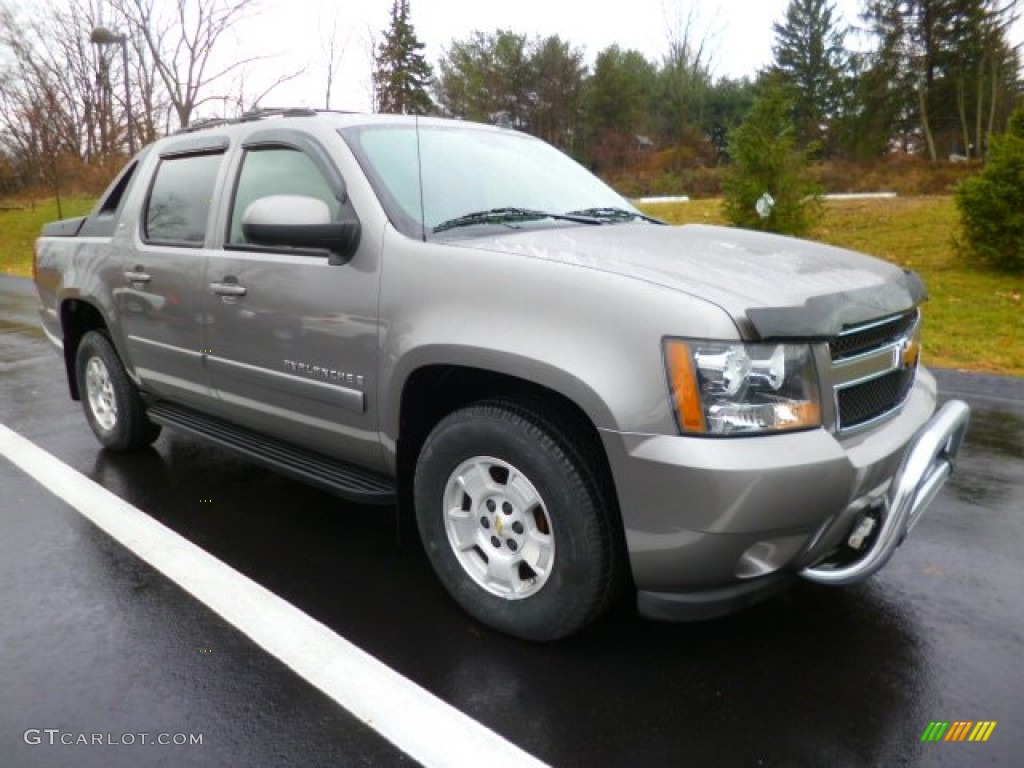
left=114, top=136, right=228, bottom=410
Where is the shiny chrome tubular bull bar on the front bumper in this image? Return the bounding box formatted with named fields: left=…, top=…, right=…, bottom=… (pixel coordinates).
left=800, top=400, right=971, bottom=586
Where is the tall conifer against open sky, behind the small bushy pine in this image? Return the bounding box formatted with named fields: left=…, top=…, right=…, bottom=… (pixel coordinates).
left=773, top=0, right=850, bottom=151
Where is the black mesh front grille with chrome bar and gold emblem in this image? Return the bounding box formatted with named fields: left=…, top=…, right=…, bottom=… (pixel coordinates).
left=828, top=309, right=920, bottom=431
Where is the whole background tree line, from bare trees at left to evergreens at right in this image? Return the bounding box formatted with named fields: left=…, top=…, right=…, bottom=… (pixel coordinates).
left=0, top=0, right=1024, bottom=198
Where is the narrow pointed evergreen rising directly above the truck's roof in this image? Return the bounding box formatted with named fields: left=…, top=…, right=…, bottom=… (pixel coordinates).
left=374, top=0, right=434, bottom=115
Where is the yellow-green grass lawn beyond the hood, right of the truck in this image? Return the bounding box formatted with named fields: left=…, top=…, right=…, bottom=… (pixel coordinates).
left=644, top=197, right=1024, bottom=376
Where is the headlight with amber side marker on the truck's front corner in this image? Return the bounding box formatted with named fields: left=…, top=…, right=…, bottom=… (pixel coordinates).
left=665, top=339, right=821, bottom=435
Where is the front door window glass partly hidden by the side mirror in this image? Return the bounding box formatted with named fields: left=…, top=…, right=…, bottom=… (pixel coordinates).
left=227, top=146, right=340, bottom=245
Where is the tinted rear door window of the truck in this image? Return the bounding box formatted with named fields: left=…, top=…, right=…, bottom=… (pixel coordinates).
left=145, top=153, right=224, bottom=246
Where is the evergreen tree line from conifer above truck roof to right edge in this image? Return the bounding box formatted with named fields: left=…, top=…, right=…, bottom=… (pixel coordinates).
left=376, top=0, right=1024, bottom=170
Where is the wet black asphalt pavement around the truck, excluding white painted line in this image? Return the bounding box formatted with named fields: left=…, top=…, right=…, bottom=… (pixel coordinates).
left=0, top=278, right=1024, bottom=768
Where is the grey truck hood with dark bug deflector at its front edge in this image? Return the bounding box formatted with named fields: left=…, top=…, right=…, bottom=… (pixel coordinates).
left=450, top=223, right=926, bottom=339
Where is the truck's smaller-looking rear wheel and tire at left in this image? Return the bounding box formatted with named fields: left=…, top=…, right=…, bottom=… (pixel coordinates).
left=75, top=331, right=160, bottom=452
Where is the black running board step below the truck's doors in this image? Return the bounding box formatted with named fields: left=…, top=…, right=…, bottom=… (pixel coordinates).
left=146, top=402, right=397, bottom=504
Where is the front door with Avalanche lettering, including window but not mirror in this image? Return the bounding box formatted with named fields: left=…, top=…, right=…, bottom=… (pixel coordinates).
left=201, top=129, right=381, bottom=467
